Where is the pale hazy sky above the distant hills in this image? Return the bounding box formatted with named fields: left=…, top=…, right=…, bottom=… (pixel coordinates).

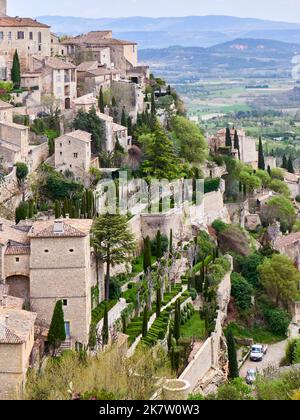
left=8, top=0, right=300, bottom=22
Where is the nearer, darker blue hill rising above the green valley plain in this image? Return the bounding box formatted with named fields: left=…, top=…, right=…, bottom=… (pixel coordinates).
left=139, top=38, right=300, bottom=83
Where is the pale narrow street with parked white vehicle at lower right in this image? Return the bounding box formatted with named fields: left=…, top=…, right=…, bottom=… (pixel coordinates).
left=240, top=340, right=287, bottom=378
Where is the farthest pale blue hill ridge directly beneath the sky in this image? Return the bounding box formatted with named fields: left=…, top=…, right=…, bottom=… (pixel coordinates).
left=37, top=16, right=300, bottom=48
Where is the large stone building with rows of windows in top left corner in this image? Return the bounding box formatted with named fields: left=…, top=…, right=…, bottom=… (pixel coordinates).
left=0, top=0, right=51, bottom=74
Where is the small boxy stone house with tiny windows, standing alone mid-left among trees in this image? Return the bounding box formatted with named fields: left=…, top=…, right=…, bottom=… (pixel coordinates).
left=55, top=130, right=99, bottom=179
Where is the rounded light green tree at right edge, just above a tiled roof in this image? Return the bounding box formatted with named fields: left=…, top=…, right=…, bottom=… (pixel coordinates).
left=261, top=196, right=296, bottom=231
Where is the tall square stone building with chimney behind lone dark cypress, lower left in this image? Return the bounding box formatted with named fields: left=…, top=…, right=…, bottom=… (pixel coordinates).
left=28, top=219, right=92, bottom=346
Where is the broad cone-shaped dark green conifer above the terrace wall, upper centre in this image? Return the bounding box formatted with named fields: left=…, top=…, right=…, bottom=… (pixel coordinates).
left=142, top=121, right=181, bottom=180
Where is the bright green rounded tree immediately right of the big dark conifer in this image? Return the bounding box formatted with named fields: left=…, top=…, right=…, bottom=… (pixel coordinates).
left=171, top=116, right=208, bottom=163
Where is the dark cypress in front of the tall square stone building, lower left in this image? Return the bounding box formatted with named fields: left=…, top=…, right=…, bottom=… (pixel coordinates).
left=48, top=300, right=66, bottom=354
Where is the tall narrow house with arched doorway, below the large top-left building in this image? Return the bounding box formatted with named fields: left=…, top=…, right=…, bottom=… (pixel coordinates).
left=32, top=56, right=77, bottom=110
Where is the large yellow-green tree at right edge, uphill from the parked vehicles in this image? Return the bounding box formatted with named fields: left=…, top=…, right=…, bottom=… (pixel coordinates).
left=258, top=254, right=300, bottom=307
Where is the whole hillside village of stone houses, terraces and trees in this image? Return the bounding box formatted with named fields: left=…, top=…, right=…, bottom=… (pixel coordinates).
left=0, top=0, right=300, bottom=399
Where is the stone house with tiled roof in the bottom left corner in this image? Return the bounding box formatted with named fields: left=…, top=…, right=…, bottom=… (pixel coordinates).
left=0, top=305, right=36, bottom=399
